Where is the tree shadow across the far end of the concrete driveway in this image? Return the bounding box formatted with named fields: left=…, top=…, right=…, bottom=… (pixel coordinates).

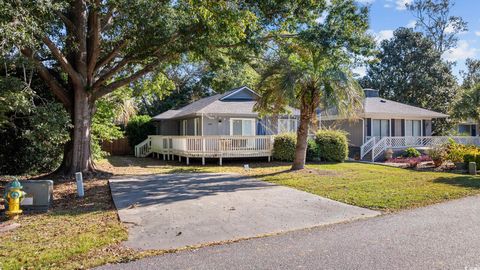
left=110, top=173, right=273, bottom=210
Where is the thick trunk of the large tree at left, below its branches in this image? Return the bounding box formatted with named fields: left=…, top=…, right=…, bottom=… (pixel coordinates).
left=59, top=88, right=95, bottom=175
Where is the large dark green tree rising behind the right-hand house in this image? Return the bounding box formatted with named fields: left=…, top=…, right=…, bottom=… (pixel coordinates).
left=361, top=28, right=457, bottom=133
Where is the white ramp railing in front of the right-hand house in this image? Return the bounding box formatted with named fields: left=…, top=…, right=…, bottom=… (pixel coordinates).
left=360, top=136, right=480, bottom=161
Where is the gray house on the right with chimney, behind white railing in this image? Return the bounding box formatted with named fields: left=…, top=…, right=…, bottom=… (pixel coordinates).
left=319, top=89, right=448, bottom=157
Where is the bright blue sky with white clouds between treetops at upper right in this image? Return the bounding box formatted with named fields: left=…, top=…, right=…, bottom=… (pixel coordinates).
left=357, top=0, right=480, bottom=78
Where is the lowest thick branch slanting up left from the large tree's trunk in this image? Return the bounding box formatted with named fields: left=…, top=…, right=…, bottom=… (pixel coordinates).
left=20, top=48, right=72, bottom=111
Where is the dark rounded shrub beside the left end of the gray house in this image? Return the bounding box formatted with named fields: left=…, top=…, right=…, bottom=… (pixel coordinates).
left=125, top=115, right=155, bottom=147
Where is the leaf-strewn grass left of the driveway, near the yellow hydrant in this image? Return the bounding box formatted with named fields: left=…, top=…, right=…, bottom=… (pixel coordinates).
left=0, top=176, right=161, bottom=269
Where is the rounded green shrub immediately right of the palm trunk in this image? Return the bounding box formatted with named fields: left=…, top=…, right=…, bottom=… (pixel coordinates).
left=315, top=130, right=348, bottom=162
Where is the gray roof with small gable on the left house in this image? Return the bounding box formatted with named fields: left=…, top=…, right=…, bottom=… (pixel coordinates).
left=153, top=86, right=298, bottom=120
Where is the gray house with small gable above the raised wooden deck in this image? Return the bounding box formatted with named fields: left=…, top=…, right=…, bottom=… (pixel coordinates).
left=153, top=86, right=299, bottom=136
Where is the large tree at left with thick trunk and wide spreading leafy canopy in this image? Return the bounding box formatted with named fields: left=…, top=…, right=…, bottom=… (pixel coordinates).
left=0, top=0, right=326, bottom=173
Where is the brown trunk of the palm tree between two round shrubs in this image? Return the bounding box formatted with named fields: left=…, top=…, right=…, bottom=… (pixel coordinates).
left=292, top=109, right=312, bottom=170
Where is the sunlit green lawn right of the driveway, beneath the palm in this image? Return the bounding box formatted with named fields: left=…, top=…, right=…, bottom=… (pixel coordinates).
left=252, top=163, right=480, bottom=211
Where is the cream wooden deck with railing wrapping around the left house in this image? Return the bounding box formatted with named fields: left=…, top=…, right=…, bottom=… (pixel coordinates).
left=135, top=135, right=273, bottom=165
